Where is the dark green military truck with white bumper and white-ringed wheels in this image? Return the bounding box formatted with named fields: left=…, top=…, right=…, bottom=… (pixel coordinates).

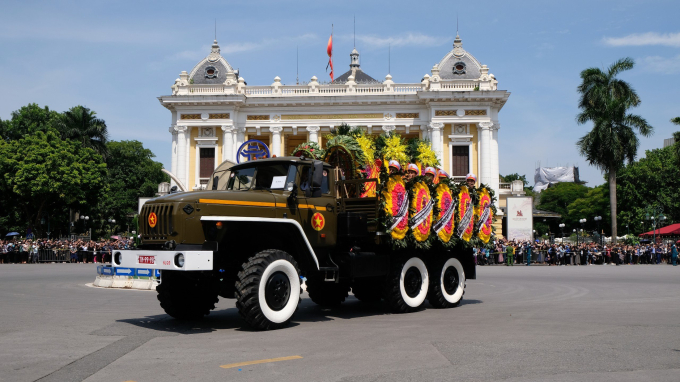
left=113, top=157, right=475, bottom=330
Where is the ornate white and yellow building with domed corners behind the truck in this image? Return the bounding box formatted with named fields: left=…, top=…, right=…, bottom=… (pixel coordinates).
left=159, top=36, right=510, bottom=205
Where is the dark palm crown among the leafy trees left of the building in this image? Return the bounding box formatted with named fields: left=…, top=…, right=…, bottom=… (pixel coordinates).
left=57, top=106, right=109, bottom=160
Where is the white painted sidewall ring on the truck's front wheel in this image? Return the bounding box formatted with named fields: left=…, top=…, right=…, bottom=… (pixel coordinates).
left=258, top=260, right=300, bottom=324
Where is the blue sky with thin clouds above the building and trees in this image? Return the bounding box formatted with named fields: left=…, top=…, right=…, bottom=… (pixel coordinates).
left=0, top=0, right=680, bottom=186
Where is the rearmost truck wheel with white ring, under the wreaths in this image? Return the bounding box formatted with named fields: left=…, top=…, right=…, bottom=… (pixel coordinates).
left=427, top=258, right=465, bottom=308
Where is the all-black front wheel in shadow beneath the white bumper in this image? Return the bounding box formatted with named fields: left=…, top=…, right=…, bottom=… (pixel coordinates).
left=156, top=271, right=218, bottom=320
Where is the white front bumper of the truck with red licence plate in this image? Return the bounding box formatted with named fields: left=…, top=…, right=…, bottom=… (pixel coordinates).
left=111, top=250, right=213, bottom=271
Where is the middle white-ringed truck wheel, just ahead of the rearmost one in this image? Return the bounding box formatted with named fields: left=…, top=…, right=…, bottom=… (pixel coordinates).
left=385, top=257, right=430, bottom=313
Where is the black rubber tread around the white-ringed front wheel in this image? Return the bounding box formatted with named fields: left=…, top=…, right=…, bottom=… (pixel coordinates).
left=236, top=249, right=300, bottom=330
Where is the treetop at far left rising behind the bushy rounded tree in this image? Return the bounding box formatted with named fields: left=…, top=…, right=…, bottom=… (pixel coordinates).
left=0, top=103, right=60, bottom=141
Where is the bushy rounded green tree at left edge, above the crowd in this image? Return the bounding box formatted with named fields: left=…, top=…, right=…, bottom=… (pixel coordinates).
left=0, top=130, right=106, bottom=233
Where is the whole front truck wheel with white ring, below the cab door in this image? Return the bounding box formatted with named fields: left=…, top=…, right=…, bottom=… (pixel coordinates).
left=236, top=249, right=300, bottom=330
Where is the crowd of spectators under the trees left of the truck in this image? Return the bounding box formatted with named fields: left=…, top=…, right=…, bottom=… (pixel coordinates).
left=0, top=239, right=133, bottom=264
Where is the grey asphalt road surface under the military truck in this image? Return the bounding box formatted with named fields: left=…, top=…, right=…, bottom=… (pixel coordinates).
left=0, top=264, right=680, bottom=382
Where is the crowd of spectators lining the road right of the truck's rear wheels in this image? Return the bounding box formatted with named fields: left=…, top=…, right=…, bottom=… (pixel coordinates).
left=474, top=239, right=678, bottom=266
